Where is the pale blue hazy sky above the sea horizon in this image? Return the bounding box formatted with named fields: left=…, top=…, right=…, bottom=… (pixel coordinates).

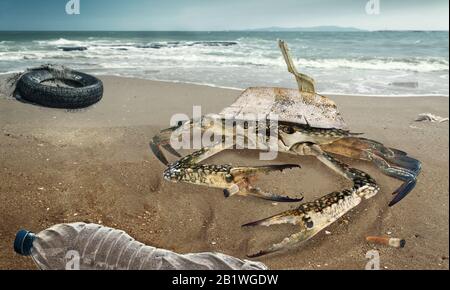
left=0, top=0, right=449, bottom=31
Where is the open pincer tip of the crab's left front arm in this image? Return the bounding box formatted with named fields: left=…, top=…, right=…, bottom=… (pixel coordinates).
left=223, top=164, right=303, bottom=202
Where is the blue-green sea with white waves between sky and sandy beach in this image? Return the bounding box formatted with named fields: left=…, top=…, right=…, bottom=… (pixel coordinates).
left=0, top=31, right=449, bottom=97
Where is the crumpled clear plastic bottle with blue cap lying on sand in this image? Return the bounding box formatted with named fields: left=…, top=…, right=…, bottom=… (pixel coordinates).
left=14, top=223, right=267, bottom=270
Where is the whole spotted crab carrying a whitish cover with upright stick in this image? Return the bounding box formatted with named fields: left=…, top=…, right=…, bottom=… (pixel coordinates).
left=150, top=41, right=421, bottom=257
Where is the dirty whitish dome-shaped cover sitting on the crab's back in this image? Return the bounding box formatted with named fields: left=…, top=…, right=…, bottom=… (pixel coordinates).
left=220, top=87, right=348, bottom=130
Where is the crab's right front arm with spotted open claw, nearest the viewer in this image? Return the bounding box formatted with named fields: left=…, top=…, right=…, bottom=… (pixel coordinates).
left=243, top=145, right=379, bottom=257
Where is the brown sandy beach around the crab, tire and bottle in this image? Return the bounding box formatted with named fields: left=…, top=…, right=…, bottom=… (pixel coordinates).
left=0, top=77, right=449, bottom=269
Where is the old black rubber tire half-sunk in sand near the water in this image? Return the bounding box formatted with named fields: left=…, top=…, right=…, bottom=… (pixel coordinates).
left=16, top=69, right=103, bottom=109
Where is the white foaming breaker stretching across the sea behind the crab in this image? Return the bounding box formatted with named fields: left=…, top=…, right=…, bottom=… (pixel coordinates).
left=0, top=46, right=449, bottom=72
